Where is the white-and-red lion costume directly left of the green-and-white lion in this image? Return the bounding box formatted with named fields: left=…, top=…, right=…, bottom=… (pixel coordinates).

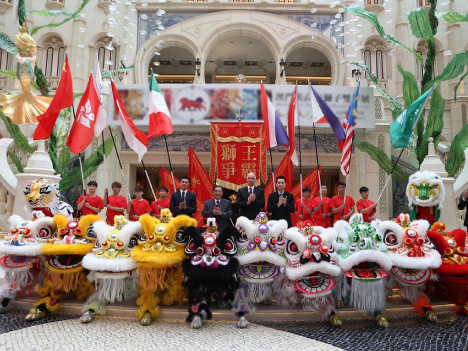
left=285, top=221, right=342, bottom=326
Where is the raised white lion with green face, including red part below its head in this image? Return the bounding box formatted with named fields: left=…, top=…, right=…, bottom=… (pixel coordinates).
left=406, top=171, right=445, bottom=225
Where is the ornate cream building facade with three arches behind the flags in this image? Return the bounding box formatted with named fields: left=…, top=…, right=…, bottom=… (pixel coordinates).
left=0, top=0, right=468, bottom=218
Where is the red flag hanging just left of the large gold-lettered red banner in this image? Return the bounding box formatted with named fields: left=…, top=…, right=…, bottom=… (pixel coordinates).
left=188, top=147, right=213, bottom=226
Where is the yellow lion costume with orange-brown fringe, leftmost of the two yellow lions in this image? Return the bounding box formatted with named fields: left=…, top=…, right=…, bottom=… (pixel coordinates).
left=26, top=214, right=101, bottom=321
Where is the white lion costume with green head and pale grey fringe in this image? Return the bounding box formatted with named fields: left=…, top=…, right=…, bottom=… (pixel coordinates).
left=333, top=214, right=392, bottom=327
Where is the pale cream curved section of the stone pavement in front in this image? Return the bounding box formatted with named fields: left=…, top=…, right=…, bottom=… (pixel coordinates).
left=0, top=317, right=340, bottom=351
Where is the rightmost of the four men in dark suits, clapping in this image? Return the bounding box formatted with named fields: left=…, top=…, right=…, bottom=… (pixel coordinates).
left=267, top=176, right=295, bottom=228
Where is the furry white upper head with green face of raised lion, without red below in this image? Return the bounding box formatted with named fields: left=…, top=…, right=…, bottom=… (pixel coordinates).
left=406, top=171, right=445, bottom=208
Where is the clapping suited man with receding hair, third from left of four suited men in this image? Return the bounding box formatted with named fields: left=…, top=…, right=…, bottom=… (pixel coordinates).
left=237, top=173, right=265, bottom=220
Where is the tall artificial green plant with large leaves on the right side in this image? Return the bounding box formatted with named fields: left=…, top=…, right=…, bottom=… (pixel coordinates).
left=343, top=0, right=468, bottom=176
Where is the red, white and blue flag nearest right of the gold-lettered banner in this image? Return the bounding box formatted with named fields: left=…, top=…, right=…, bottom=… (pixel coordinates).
left=260, top=83, right=289, bottom=148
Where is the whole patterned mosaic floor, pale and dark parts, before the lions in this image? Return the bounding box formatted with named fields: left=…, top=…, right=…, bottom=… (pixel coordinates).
left=0, top=310, right=468, bottom=351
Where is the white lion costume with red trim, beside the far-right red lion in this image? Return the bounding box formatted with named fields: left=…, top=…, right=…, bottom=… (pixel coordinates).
left=372, top=213, right=442, bottom=322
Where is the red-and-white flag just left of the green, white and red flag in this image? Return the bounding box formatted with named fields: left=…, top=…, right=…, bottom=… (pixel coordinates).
left=111, top=78, right=148, bottom=162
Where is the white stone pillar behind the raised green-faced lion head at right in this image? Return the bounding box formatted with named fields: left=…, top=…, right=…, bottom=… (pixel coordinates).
left=420, top=138, right=460, bottom=231
